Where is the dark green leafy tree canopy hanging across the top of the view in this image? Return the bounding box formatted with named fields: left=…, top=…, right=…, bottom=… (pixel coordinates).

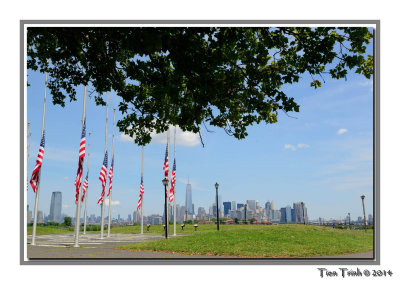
left=27, top=27, right=373, bottom=145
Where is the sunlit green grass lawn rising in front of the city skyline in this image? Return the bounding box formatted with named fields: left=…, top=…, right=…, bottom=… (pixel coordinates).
left=118, top=225, right=373, bottom=257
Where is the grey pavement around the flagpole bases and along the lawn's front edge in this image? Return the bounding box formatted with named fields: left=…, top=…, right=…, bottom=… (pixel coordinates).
left=27, top=233, right=373, bottom=260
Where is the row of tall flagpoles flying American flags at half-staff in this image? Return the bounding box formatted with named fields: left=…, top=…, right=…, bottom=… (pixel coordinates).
left=27, top=73, right=176, bottom=247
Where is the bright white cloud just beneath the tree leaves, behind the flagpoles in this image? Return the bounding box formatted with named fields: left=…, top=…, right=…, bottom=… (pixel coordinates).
left=119, top=126, right=200, bottom=147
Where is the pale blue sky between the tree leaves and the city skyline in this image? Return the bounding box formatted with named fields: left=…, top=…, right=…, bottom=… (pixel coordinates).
left=27, top=46, right=373, bottom=219
